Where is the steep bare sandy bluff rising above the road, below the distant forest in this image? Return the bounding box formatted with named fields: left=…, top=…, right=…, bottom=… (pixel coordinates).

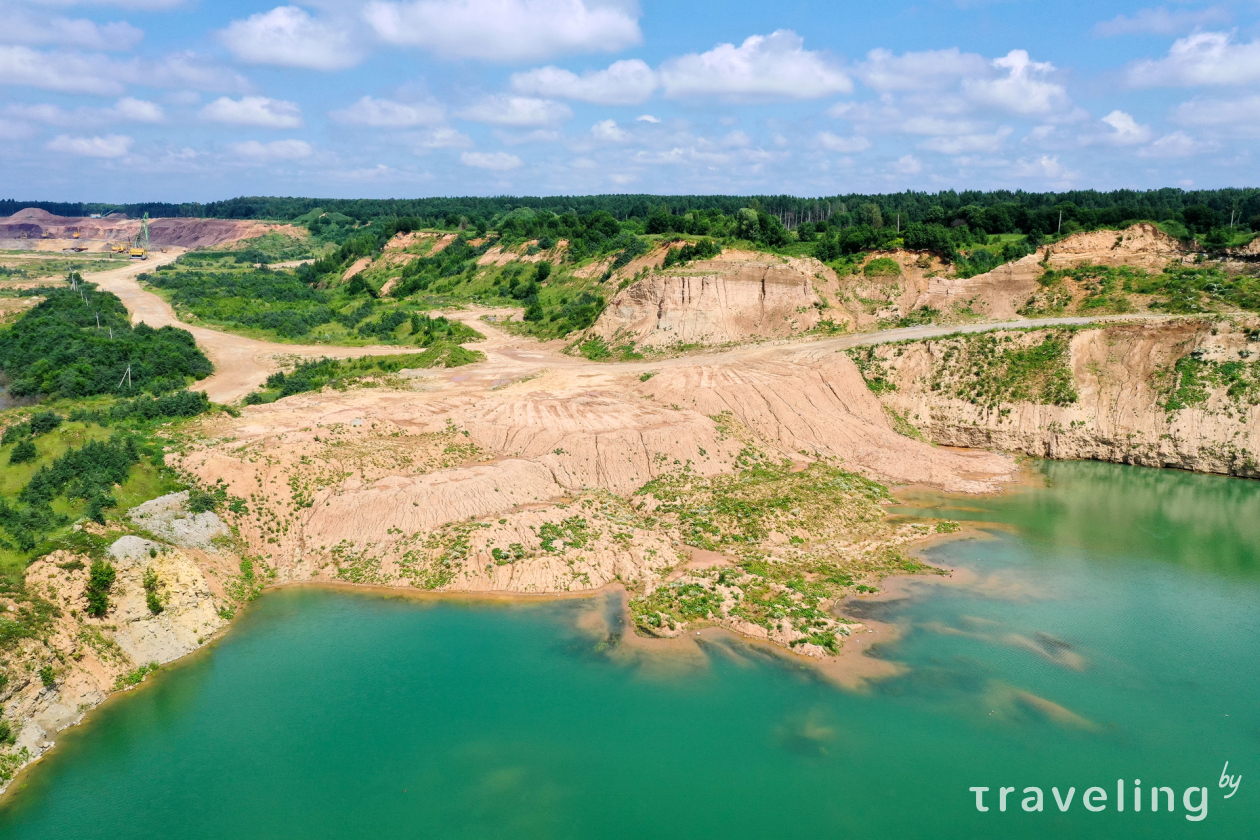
left=592, top=254, right=822, bottom=348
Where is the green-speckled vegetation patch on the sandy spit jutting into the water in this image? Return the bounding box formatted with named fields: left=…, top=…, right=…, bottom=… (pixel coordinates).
left=630, top=450, right=926, bottom=652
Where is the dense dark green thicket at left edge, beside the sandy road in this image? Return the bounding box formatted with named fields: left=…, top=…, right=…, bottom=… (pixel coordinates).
left=0, top=275, right=213, bottom=397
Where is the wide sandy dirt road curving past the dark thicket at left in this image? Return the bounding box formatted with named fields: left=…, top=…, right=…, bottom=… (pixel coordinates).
left=84, top=248, right=417, bottom=403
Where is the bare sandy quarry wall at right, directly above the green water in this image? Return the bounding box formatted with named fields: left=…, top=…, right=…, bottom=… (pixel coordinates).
left=878, top=320, right=1260, bottom=477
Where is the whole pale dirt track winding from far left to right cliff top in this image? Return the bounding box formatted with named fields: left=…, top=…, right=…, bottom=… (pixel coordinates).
left=87, top=248, right=1168, bottom=403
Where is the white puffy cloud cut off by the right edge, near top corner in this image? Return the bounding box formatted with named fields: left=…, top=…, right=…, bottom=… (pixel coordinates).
left=1128, top=31, right=1260, bottom=87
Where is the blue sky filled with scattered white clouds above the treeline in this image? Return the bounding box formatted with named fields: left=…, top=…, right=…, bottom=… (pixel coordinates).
left=0, top=0, right=1260, bottom=201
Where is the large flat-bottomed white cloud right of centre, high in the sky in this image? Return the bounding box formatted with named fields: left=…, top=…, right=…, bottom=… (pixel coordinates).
left=660, top=29, right=853, bottom=99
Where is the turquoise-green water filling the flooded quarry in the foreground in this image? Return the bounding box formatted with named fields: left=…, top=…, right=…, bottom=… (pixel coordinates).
left=0, top=463, right=1260, bottom=840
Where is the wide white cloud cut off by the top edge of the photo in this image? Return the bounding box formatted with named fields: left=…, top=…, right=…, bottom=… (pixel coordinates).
left=364, top=0, right=643, bottom=62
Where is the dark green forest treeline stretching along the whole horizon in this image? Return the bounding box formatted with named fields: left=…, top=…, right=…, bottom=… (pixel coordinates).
left=7, top=188, right=1260, bottom=234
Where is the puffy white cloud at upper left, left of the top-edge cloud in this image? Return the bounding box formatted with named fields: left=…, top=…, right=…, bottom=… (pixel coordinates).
left=219, top=6, right=363, bottom=71
